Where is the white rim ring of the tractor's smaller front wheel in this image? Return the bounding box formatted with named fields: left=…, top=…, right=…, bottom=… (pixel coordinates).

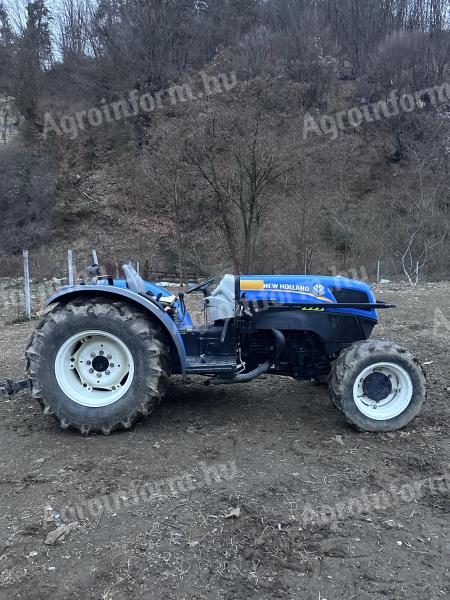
left=353, top=362, right=413, bottom=421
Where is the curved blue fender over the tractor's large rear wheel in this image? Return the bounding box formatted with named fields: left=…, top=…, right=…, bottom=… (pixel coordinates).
left=44, top=285, right=187, bottom=377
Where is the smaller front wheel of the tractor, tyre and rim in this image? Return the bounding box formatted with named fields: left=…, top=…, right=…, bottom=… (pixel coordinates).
left=329, top=340, right=426, bottom=432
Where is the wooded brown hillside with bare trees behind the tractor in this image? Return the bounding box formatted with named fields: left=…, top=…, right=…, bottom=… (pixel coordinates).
left=0, top=2, right=450, bottom=279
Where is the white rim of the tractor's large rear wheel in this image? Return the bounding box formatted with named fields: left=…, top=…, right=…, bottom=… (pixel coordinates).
left=55, top=331, right=134, bottom=408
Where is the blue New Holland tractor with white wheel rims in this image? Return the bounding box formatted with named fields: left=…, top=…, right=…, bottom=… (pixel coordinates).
left=26, top=265, right=426, bottom=435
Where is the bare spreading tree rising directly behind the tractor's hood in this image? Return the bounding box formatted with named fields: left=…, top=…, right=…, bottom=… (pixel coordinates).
left=186, top=117, right=294, bottom=273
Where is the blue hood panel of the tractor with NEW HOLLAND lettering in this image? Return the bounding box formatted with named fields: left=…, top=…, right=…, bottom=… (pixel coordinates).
left=241, top=275, right=378, bottom=321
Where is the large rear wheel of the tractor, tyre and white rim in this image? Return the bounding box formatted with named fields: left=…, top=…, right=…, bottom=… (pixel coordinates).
left=26, top=297, right=170, bottom=435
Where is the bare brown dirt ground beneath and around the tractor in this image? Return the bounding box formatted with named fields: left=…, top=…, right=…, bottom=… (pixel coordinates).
left=0, top=283, right=450, bottom=600
